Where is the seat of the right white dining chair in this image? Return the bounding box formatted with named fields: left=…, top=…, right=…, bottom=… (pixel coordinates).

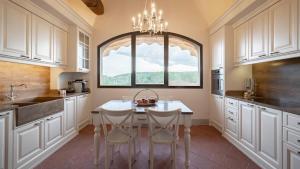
left=152, top=129, right=176, bottom=144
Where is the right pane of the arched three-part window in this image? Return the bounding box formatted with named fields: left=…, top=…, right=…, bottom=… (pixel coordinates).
left=168, top=36, right=200, bottom=86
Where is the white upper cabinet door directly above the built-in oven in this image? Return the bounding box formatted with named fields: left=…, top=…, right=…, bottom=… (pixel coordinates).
left=210, top=30, right=224, bottom=70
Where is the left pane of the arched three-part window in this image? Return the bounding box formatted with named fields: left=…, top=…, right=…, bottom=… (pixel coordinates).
left=100, top=36, right=131, bottom=86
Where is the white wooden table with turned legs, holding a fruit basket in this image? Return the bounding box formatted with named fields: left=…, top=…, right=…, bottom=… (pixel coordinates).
left=92, top=100, right=193, bottom=169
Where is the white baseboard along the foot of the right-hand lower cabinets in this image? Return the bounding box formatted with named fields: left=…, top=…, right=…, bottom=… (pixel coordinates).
left=223, top=133, right=276, bottom=169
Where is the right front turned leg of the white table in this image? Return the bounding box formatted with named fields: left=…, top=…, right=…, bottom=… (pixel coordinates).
left=184, top=115, right=192, bottom=169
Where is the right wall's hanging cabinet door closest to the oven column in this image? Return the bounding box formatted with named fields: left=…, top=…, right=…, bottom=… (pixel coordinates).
left=234, top=23, right=249, bottom=63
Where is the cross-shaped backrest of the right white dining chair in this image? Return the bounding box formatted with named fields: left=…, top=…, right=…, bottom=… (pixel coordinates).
left=146, top=109, right=181, bottom=136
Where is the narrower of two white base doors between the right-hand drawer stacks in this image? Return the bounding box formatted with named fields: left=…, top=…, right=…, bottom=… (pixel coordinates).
left=239, top=102, right=256, bottom=151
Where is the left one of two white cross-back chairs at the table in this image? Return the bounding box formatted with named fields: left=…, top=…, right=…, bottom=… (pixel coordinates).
left=100, top=108, right=137, bottom=169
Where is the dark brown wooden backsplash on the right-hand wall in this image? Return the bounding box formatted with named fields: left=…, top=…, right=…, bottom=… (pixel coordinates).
left=252, top=58, right=300, bottom=104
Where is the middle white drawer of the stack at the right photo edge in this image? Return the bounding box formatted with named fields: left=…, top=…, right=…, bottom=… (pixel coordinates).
left=283, top=127, right=300, bottom=149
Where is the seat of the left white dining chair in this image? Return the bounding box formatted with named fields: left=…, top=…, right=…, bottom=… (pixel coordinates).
left=107, top=128, right=137, bottom=144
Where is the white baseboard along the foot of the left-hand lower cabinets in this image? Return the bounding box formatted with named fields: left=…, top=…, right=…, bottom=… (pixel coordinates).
left=18, top=131, right=78, bottom=169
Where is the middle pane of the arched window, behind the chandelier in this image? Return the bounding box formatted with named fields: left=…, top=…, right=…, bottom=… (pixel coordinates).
left=136, top=35, right=164, bottom=85
